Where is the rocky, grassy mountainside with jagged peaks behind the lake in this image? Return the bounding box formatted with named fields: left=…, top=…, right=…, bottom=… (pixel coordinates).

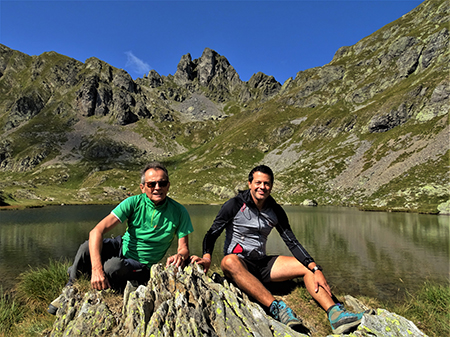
left=0, top=1, right=450, bottom=212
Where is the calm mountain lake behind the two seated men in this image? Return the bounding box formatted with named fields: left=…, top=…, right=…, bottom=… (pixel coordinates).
left=0, top=205, right=450, bottom=300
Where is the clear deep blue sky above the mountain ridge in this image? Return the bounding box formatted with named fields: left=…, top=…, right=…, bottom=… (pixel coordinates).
left=0, top=0, right=422, bottom=83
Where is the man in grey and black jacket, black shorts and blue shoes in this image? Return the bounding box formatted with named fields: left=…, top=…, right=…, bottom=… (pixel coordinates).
left=191, top=165, right=363, bottom=334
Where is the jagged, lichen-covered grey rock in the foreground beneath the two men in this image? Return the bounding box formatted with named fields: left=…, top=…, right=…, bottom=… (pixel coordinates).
left=48, top=264, right=425, bottom=337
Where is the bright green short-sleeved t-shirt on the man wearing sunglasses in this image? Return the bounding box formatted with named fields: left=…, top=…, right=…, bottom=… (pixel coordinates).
left=112, top=193, right=194, bottom=266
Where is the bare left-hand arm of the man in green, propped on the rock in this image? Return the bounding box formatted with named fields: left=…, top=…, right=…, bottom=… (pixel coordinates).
left=89, top=213, right=120, bottom=290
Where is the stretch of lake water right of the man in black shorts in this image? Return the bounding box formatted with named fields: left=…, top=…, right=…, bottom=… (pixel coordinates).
left=266, top=207, right=449, bottom=299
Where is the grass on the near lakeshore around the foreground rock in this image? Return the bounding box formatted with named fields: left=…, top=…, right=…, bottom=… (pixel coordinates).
left=0, top=261, right=450, bottom=337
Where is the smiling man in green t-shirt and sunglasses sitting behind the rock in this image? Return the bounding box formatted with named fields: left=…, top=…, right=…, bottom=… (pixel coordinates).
left=48, top=162, right=194, bottom=314
